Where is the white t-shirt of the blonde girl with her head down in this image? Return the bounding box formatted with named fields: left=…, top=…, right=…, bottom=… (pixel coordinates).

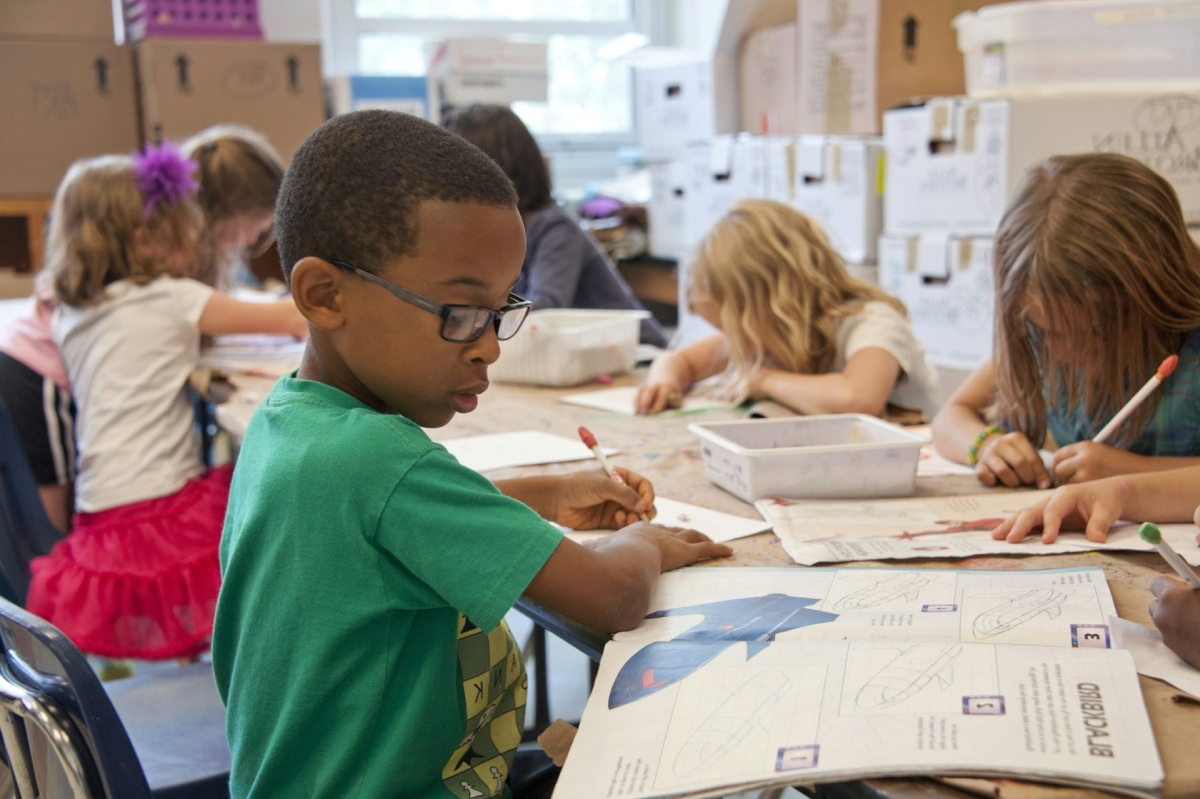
left=829, top=301, right=937, bottom=419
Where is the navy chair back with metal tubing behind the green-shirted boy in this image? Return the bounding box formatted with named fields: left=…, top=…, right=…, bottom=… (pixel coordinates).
left=0, top=599, right=151, bottom=799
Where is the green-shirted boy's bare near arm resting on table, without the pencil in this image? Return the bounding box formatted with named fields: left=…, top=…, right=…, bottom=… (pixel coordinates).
left=524, top=523, right=733, bottom=632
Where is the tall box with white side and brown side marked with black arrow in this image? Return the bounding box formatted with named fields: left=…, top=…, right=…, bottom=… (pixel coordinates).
left=796, top=0, right=990, bottom=136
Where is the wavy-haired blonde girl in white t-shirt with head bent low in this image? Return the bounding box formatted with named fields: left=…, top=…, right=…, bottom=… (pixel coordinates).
left=635, top=200, right=936, bottom=415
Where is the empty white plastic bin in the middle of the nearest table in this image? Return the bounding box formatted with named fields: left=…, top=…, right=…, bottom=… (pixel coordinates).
left=688, top=414, right=926, bottom=503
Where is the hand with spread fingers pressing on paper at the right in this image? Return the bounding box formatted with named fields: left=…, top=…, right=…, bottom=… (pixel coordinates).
left=991, top=483, right=1122, bottom=543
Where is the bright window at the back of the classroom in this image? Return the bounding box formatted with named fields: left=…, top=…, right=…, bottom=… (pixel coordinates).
left=326, top=0, right=662, bottom=137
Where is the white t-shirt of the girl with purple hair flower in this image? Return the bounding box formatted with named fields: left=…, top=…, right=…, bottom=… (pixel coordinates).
left=54, top=277, right=212, bottom=512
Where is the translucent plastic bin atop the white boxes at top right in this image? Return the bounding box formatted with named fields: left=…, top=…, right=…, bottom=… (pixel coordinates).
left=954, top=0, right=1200, bottom=97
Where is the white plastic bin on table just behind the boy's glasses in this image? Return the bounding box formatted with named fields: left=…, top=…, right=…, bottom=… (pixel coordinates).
left=488, top=308, right=650, bottom=385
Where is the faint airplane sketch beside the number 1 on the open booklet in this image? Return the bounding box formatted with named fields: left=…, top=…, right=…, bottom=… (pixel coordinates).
left=674, top=669, right=792, bottom=777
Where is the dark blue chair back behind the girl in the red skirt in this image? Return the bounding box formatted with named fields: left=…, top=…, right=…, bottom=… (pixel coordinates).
left=0, top=404, right=62, bottom=606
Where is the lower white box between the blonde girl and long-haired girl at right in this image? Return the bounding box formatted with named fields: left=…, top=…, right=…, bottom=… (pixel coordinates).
left=878, top=234, right=995, bottom=370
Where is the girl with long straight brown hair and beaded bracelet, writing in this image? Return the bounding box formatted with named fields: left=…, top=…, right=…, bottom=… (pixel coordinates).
left=934, top=148, right=1200, bottom=487
